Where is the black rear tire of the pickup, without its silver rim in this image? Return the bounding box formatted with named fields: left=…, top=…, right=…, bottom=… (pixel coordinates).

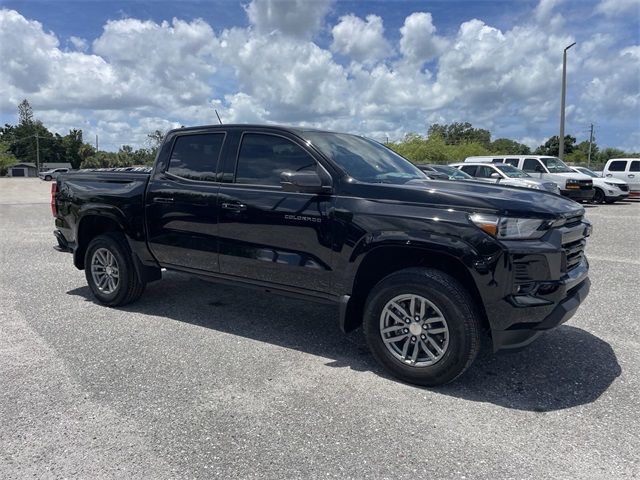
left=84, top=232, right=146, bottom=307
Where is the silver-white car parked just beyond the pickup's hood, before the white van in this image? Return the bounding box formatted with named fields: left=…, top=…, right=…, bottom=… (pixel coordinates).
left=451, top=162, right=560, bottom=195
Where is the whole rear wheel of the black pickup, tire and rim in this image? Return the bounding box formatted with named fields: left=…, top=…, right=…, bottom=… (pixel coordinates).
left=84, top=233, right=145, bottom=307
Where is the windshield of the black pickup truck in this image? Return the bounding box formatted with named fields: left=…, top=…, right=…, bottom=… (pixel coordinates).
left=303, top=131, right=428, bottom=184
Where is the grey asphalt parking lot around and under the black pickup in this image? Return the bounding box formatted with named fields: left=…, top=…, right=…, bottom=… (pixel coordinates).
left=0, top=179, right=640, bottom=479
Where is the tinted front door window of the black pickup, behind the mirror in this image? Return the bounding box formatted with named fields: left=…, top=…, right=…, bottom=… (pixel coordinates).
left=236, top=133, right=316, bottom=185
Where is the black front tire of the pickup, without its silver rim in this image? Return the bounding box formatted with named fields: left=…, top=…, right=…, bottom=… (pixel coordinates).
left=363, top=268, right=481, bottom=386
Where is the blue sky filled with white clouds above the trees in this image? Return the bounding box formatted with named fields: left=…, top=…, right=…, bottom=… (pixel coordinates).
left=0, top=0, right=640, bottom=151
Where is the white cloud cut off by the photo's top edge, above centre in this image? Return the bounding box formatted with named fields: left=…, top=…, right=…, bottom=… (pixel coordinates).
left=245, top=0, right=333, bottom=38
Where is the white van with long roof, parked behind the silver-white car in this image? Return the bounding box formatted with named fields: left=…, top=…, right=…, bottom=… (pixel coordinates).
left=464, top=155, right=594, bottom=202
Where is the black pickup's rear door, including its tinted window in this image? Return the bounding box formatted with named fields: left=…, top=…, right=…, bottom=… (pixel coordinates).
left=146, top=129, right=226, bottom=272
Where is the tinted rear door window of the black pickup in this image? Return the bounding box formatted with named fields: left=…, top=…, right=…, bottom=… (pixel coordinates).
left=168, top=133, right=224, bottom=182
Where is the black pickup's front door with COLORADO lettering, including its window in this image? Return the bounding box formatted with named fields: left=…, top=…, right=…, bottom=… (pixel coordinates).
left=218, top=131, right=333, bottom=293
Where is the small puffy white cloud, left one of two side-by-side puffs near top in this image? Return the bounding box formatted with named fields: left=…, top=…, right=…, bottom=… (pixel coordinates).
left=331, top=15, right=393, bottom=62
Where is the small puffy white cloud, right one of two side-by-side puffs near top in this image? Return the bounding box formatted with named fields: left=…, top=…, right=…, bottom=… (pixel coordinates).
left=400, top=12, right=447, bottom=66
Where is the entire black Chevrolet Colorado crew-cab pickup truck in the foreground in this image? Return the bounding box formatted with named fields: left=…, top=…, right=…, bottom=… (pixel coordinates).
left=51, top=125, right=591, bottom=385
